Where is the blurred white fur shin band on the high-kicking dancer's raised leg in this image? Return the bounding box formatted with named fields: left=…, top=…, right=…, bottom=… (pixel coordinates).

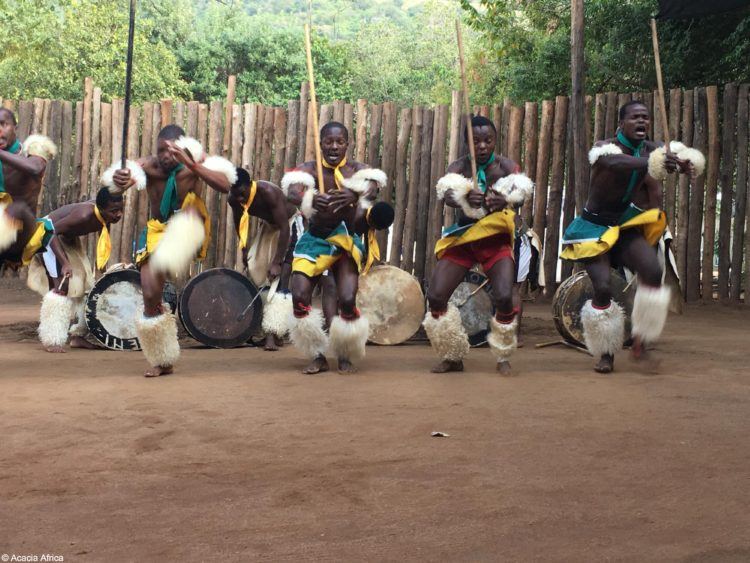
left=149, top=211, right=206, bottom=276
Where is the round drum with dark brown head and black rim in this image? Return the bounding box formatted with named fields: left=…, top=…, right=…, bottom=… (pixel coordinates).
left=179, top=268, right=263, bottom=348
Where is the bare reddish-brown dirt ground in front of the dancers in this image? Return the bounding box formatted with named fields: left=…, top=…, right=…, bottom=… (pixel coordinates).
left=0, top=280, right=750, bottom=562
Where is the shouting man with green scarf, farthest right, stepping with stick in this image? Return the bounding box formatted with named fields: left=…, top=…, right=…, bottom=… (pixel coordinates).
left=560, top=100, right=702, bottom=373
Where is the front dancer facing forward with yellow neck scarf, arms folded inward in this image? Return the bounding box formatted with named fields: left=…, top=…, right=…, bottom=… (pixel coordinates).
left=281, top=122, right=387, bottom=374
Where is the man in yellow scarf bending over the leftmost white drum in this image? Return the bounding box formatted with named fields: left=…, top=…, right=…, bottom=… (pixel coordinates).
left=27, top=186, right=123, bottom=352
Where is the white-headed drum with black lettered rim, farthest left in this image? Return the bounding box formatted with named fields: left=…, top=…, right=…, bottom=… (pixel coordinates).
left=85, top=268, right=177, bottom=350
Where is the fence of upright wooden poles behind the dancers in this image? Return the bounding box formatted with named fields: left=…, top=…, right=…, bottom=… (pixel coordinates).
left=3, top=78, right=750, bottom=303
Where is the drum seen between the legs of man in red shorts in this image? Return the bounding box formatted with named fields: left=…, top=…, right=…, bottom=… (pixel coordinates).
left=450, top=270, right=495, bottom=346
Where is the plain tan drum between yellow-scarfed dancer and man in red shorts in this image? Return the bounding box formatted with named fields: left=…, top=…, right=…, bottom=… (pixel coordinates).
left=357, top=265, right=425, bottom=345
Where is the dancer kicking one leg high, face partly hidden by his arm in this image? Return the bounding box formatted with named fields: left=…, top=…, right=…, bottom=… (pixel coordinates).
left=114, top=125, right=237, bottom=377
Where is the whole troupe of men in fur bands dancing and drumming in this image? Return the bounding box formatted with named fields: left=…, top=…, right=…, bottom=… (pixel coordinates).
left=0, top=101, right=705, bottom=377
